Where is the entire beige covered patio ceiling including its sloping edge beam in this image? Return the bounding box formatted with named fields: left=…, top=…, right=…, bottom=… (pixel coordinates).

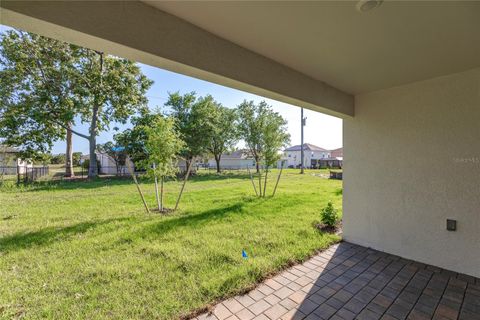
left=0, top=0, right=480, bottom=118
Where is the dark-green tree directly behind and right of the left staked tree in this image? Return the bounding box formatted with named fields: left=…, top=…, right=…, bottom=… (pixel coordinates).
left=165, top=92, right=213, bottom=167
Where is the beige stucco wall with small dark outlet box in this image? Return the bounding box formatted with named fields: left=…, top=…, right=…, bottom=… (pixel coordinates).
left=343, top=69, right=480, bottom=277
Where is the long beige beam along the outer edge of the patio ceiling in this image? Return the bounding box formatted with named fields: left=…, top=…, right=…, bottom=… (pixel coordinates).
left=0, top=0, right=354, bottom=118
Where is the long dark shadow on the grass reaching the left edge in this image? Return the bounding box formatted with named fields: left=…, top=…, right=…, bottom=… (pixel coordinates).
left=0, top=218, right=131, bottom=252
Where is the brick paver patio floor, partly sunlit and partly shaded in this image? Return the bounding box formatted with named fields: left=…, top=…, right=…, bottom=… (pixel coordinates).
left=196, top=242, right=480, bottom=320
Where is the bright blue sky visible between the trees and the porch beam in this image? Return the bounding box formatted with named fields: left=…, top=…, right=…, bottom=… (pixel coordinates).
left=0, top=25, right=343, bottom=154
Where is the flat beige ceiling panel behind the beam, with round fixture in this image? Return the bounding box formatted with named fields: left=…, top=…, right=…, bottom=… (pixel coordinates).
left=145, top=0, right=480, bottom=94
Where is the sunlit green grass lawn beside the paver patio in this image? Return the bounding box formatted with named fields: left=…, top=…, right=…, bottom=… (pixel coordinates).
left=0, top=170, right=342, bottom=319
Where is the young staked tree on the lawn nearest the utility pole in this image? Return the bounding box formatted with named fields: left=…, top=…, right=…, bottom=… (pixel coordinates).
left=238, top=101, right=290, bottom=196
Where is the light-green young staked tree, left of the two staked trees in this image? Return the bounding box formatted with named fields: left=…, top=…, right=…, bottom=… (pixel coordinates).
left=140, top=116, right=184, bottom=212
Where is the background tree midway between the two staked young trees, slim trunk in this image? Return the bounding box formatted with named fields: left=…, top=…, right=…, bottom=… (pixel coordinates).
left=204, top=96, right=238, bottom=172
